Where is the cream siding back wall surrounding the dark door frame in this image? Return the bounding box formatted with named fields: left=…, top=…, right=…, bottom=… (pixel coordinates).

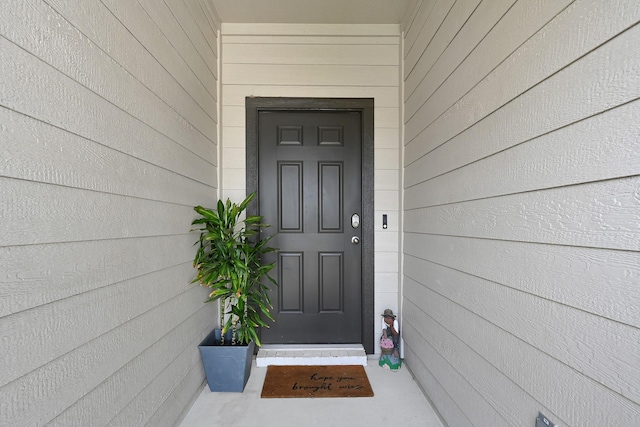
left=221, top=24, right=401, bottom=348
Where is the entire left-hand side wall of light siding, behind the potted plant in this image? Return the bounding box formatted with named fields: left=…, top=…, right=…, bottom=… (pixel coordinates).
left=0, top=0, right=218, bottom=426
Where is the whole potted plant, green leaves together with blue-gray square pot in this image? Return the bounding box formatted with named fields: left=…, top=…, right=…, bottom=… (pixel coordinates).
left=192, top=193, right=277, bottom=391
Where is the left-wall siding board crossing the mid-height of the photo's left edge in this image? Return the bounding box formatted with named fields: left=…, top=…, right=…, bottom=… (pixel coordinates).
left=0, top=178, right=194, bottom=246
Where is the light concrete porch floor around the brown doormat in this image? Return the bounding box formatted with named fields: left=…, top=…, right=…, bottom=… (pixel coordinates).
left=180, top=355, right=443, bottom=427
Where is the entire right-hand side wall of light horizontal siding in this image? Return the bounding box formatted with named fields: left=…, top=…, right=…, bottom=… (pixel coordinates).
left=403, top=0, right=640, bottom=427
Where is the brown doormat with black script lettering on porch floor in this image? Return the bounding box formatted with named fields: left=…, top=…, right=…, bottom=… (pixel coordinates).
left=261, top=365, right=373, bottom=398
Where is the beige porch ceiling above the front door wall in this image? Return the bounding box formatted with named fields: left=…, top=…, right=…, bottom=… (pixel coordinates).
left=211, top=0, right=415, bottom=24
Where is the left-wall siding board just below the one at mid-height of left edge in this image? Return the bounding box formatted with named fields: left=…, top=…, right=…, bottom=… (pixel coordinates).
left=0, top=235, right=194, bottom=316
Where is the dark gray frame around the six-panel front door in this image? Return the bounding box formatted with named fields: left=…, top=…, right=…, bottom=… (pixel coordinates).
left=245, top=97, right=374, bottom=354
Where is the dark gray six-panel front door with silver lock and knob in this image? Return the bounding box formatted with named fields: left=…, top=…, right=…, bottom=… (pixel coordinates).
left=245, top=98, right=372, bottom=352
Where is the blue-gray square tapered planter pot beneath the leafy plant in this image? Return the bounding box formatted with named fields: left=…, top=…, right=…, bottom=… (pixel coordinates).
left=198, top=329, right=255, bottom=392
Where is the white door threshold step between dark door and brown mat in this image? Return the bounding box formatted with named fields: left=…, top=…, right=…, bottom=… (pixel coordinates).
left=256, top=344, right=367, bottom=367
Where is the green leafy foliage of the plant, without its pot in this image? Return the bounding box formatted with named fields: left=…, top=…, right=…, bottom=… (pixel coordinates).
left=192, top=193, right=278, bottom=346
